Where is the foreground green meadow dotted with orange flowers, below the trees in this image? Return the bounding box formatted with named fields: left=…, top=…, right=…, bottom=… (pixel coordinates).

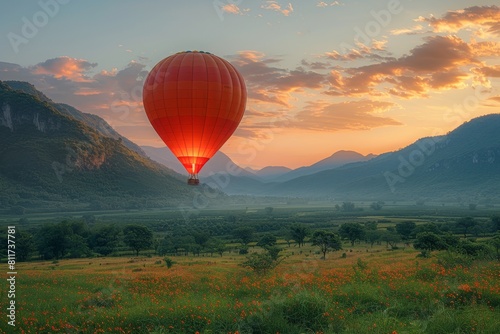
left=0, top=244, right=500, bottom=334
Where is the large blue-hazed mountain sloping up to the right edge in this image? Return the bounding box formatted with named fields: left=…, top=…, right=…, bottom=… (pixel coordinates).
left=268, top=114, right=500, bottom=201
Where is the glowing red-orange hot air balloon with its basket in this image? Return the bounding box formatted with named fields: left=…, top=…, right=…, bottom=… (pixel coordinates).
left=143, top=51, right=247, bottom=185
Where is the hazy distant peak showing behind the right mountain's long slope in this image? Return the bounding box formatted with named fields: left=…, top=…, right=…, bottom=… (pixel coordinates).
left=274, top=151, right=375, bottom=182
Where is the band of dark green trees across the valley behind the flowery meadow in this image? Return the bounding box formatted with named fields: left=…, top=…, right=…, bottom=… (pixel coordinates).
left=2, top=216, right=500, bottom=261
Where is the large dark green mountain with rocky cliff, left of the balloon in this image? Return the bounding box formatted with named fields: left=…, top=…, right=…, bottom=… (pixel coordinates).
left=0, top=81, right=205, bottom=210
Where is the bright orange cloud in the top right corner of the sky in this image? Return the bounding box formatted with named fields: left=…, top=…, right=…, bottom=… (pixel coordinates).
left=420, top=6, right=500, bottom=36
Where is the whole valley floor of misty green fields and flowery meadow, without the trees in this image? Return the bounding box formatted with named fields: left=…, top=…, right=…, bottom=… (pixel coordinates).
left=0, top=203, right=500, bottom=334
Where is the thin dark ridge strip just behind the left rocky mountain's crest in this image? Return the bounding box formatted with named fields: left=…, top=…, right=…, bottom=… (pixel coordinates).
left=4, top=81, right=146, bottom=156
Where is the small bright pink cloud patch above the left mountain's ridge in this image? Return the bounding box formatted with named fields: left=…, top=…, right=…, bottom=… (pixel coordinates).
left=32, top=57, right=97, bottom=82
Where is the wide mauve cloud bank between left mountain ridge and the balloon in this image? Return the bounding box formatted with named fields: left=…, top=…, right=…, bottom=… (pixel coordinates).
left=0, top=57, right=148, bottom=126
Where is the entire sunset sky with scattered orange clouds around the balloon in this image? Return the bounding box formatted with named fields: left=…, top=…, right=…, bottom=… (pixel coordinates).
left=0, top=0, right=500, bottom=168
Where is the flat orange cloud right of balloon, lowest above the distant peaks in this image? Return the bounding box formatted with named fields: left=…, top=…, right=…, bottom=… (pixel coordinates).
left=290, top=100, right=401, bottom=131
